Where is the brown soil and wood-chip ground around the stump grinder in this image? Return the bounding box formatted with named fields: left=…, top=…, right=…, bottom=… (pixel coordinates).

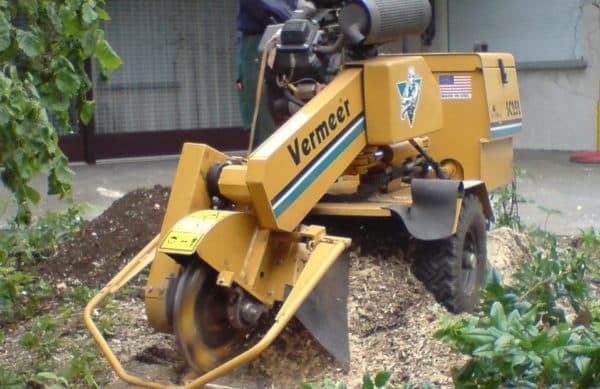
left=0, top=186, right=526, bottom=388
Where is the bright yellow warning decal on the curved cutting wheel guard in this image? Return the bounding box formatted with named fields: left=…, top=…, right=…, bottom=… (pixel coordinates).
left=159, top=210, right=232, bottom=254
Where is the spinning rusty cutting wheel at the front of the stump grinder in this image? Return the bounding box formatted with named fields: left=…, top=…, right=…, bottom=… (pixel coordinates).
left=173, top=261, right=247, bottom=372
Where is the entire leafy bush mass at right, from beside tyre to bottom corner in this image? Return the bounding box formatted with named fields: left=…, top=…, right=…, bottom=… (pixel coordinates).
left=436, top=226, right=600, bottom=388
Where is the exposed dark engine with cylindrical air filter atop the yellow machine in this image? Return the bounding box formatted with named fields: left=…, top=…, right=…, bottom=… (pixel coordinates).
left=260, top=0, right=431, bottom=124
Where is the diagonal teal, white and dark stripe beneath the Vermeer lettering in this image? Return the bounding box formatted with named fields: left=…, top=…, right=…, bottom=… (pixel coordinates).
left=271, top=114, right=365, bottom=218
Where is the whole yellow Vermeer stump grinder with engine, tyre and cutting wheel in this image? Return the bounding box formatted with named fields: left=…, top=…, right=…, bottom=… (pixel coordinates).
left=84, top=0, right=521, bottom=388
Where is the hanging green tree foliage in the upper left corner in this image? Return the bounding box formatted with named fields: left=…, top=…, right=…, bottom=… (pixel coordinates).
left=0, top=0, right=121, bottom=223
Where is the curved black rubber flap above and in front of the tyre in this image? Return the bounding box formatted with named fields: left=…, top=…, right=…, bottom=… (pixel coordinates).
left=388, top=179, right=464, bottom=240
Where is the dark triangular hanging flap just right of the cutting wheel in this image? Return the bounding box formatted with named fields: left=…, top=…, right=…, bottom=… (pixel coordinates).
left=296, top=252, right=350, bottom=369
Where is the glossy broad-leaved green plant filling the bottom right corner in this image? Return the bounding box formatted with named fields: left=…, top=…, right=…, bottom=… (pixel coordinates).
left=437, top=296, right=600, bottom=388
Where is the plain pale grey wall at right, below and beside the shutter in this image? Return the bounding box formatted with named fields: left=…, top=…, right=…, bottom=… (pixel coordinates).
left=515, top=0, right=600, bottom=150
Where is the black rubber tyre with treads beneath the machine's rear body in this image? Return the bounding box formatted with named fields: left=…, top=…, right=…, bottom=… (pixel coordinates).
left=414, top=195, right=487, bottom=312
